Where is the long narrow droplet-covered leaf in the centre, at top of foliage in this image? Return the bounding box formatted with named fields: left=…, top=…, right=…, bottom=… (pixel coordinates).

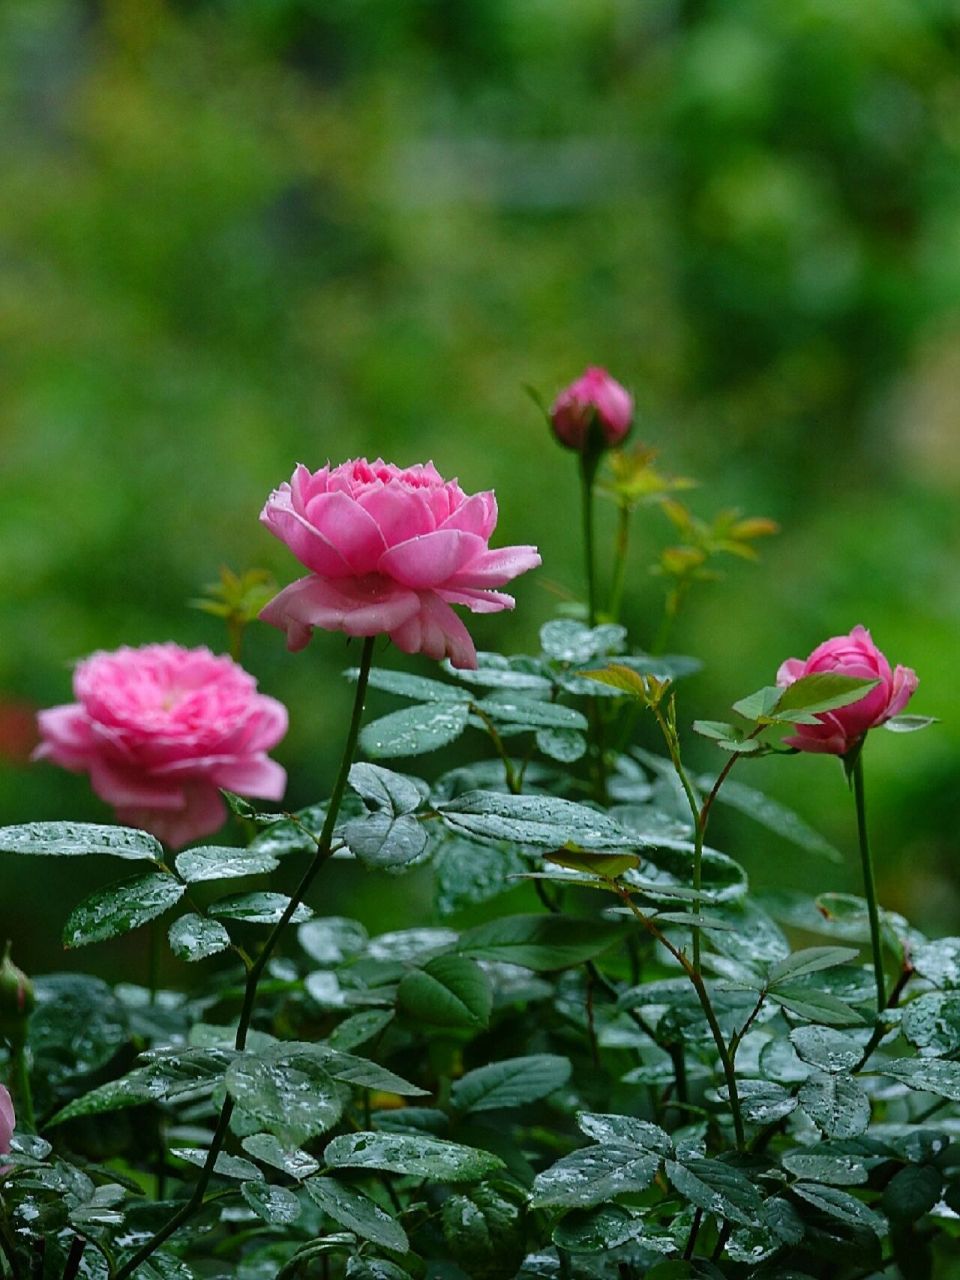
left=438, top=791, right=646, bottom=850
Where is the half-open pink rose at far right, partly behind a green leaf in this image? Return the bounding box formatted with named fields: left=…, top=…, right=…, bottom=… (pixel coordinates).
left=777, top=626, right=916, bottom=755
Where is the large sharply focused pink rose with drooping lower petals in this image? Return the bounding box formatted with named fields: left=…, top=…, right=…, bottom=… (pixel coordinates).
left=260, top=458, right=540, bottom=667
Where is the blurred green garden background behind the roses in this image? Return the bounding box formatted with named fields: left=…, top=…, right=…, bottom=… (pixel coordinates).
left=0, top=0, right=960, bottom=969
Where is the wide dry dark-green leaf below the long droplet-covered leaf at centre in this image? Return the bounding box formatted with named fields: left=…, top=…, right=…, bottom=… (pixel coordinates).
left=457, top=915, right=627, bottom=972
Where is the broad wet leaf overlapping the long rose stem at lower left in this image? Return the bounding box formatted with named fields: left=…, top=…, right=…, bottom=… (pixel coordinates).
left=227, top=1043, right=349, bottom=1142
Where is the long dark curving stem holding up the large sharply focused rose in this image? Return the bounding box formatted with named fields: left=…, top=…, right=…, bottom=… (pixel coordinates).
left=113, top=636, right=376, bottom=1280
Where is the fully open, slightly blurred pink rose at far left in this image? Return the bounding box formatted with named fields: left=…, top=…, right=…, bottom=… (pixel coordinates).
left=35, top=644, right=287, bottom=849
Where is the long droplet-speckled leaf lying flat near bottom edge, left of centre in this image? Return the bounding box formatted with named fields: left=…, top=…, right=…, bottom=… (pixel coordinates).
left=324, top=1132, right=503, bottom=1183
